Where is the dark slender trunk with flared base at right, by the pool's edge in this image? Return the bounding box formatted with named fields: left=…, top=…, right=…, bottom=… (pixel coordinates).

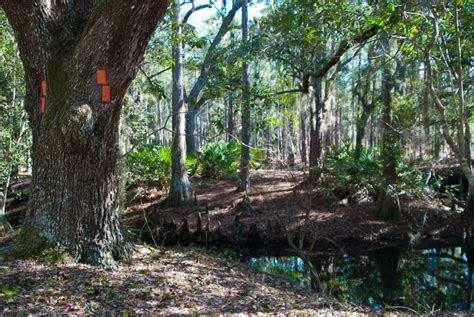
left=375, top=32, right=400, bottom=221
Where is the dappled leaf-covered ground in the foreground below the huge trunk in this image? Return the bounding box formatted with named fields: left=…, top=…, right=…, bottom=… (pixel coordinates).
left=0, top=247, right=368, bottom=316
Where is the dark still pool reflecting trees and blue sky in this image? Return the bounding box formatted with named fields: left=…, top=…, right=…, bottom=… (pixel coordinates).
left=248, top=247, right=474, bottom=312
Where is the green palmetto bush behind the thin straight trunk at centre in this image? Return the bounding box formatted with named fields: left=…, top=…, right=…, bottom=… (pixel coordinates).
left=197, top=141, right=263, bottom=178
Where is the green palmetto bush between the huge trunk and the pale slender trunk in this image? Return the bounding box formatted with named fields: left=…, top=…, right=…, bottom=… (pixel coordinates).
left=127, top=144, right=196, bottom=185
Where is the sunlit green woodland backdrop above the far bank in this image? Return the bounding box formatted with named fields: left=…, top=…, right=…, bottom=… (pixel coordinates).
left=1, top=1, right=474, bottom=218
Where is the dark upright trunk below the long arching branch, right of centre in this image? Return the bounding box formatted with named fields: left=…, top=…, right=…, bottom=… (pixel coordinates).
left=309, top=77, right=323, bottom=182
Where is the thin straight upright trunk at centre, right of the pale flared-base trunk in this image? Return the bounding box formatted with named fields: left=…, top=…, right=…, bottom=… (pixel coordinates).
left=239, top=0, right=250, bottom=192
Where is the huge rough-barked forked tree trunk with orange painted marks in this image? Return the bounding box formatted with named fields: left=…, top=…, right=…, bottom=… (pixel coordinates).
left=0, top=0, right=169, bottom=265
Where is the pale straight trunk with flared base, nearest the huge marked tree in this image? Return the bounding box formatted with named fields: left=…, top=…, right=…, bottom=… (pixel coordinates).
left=166, top=0, right=194, bottom=207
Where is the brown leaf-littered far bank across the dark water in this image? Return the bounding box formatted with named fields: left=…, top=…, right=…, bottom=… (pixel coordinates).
left=124, top=170, right=472, bottom=254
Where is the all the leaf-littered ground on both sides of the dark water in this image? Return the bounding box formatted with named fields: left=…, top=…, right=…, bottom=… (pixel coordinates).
left=0, top=170, right=472, bottom=316
